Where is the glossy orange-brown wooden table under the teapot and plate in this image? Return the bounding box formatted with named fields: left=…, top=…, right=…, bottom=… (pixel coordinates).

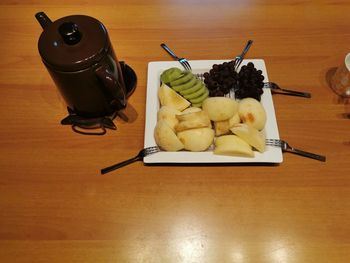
left=0, top=0, right=350, bottom=263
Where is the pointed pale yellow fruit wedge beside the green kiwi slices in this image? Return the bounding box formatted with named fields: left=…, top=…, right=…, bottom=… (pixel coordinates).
left=158, top=83, right=191, bottom=111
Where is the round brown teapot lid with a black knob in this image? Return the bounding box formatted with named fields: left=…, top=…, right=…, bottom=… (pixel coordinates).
left=38, top=15, right=109, bottom=71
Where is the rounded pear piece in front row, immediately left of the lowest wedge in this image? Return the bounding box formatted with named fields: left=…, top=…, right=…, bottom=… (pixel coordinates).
left=177, top=128, right=214, bottom=152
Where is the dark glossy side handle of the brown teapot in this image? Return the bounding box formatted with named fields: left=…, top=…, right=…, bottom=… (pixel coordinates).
left=95, top=65, right=126, bottom=111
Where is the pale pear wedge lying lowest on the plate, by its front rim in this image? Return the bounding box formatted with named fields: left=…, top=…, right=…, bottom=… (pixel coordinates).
left=214, top=135, right=254, bottom=157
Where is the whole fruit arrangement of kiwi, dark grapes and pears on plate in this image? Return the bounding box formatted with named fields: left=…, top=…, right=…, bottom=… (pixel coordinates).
left=154, top=62, right=266, bottom=157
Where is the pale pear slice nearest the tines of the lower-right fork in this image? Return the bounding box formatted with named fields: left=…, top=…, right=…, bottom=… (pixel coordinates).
left=230, top=123, right=265, bottom=152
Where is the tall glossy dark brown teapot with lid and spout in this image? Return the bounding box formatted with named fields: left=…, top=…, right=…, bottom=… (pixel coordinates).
left=35, top=12, right=135, bottom=134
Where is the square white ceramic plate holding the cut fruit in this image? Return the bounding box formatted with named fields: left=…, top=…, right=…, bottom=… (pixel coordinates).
left=143, top=59, right=283, bottom=164
